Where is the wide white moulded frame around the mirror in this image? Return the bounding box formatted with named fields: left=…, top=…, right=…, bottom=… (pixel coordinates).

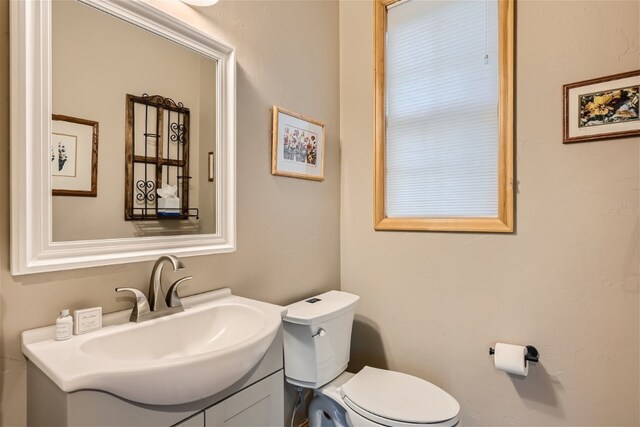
left=10, top=0, right=236, bottom=275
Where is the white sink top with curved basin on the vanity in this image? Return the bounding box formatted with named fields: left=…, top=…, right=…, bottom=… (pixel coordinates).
left=22, top=289, right=286, bottom=405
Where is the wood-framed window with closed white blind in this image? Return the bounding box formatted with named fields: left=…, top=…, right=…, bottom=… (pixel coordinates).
left=374, top=0, right=513, bottom=232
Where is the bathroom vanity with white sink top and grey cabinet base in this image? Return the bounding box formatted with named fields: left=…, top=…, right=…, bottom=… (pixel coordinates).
left=22, top=289, right=286, bottom=427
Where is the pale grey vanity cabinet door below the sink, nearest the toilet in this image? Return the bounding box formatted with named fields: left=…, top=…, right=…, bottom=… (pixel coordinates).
left=205, top=370, right=284, bottom=427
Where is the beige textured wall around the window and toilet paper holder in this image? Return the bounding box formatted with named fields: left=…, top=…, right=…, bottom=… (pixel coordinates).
left=340, top=0, right=640, bottom=426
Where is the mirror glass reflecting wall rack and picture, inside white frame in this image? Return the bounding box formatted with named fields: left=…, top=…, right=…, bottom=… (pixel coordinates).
left=51, top=1, right=217, bottom=241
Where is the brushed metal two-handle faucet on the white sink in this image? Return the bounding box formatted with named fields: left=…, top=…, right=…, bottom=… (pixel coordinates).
left=116, top=255, right=192, bottom=322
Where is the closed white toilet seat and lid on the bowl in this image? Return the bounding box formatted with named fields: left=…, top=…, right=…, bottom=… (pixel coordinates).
left=340, top=366, right=460, bottom=427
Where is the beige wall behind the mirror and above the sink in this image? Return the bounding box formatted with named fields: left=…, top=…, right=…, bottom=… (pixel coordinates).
left=0, top=0, right=340, bottom=426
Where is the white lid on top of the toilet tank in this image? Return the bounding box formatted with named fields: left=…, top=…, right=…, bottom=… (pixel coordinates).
left=284, top=291, right=360, bottom=325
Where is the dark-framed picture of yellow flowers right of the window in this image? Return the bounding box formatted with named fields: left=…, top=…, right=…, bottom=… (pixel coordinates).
left=562, top=70, right=640, bottom=144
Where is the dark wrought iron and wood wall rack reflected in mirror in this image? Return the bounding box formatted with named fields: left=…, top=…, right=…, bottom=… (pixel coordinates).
left=125, top=93, right=198, bottom=220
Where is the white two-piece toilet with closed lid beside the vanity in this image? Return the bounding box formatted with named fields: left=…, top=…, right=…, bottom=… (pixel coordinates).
left=284, top=291, right=460, bottom=427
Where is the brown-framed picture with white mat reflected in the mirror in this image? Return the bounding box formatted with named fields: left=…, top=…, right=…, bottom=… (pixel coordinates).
left=50, top=114, right=98, bottom=197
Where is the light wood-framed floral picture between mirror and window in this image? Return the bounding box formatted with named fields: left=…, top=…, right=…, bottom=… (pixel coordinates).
left=271, top=105, right=325, bottom=181
